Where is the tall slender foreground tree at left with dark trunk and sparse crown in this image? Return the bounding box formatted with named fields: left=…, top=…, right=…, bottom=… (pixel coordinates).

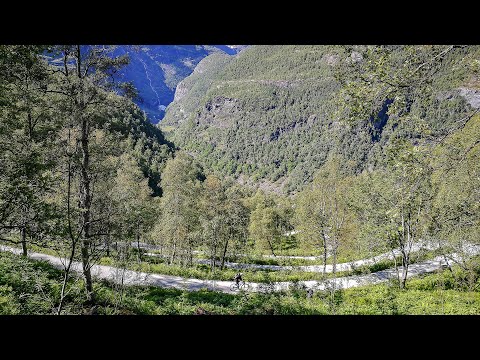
left=47, top=45, right=131, bottom=303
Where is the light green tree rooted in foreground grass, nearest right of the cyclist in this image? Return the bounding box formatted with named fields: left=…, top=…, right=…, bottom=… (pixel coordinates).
left=352, top=139, right=432, bottom=288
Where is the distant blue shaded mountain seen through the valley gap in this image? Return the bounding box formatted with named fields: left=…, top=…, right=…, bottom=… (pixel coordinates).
left=115, top=45, right=245, bottom=123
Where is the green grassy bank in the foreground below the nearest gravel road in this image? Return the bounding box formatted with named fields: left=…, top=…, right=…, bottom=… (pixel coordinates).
left=0, top=253, right=480, bottom=314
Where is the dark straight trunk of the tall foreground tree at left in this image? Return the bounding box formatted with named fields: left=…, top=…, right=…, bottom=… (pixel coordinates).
left=79, top=119, right=94, bottom=304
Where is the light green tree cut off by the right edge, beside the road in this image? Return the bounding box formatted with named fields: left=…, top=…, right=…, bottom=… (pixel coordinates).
left=431, top=115, right=480, bottom=288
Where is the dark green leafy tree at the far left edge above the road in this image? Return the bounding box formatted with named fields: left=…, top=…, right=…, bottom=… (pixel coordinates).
left=0, top=45, right=58, bottom=256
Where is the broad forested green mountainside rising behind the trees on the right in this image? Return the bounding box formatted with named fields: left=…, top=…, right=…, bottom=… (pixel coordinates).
left=159, top=45, right=480, bottom=193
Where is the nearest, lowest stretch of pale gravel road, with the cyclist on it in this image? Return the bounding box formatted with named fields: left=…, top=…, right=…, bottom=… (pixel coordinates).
left=0, top=245, right=480, bottom=293
